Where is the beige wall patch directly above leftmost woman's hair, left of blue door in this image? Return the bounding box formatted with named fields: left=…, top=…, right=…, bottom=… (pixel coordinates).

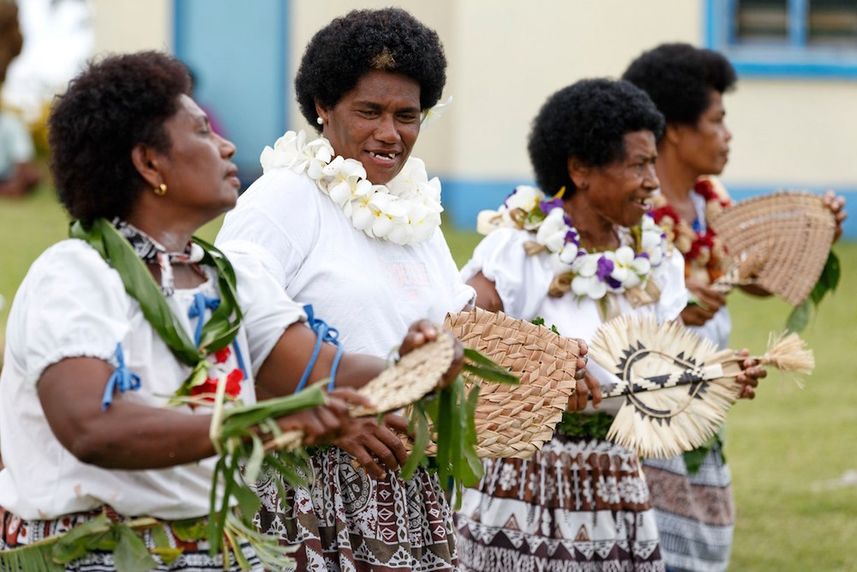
left=92, top=0, right=173, bottom=54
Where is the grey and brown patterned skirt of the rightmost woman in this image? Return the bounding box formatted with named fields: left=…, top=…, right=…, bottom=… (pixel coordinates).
left=643, top=448, right=735, bottom=572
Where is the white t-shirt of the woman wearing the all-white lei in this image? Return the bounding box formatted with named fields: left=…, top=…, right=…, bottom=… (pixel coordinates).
left=217, top=168, right=473, bottom=357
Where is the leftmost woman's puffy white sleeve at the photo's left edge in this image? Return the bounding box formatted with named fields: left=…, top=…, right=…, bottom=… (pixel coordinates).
left=9, top=240, right=131, bottom=383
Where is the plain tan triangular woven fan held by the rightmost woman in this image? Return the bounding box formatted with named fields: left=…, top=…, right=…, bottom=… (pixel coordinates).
left=708, top=191, right=836, bottom=306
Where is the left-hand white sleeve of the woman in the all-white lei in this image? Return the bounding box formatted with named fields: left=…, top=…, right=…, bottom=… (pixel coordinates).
left=216, top=169, right=321, bottom=288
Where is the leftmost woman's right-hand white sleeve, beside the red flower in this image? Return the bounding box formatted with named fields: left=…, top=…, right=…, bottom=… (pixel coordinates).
left=227, top=244, right=306, bottom=374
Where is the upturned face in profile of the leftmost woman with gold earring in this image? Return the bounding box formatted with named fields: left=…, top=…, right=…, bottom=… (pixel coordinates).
left=157, top=95, right=241, bottom=220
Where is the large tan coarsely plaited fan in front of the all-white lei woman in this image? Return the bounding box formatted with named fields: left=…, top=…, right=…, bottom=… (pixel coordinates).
left=445, top=308, right=579, bottom=458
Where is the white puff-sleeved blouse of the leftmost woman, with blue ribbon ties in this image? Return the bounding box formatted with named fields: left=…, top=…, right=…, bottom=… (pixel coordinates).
left=0, top=239, right=305, bottom=519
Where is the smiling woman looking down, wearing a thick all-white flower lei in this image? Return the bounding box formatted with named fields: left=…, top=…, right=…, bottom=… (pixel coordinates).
left=218, top=8, right=473, bottom=572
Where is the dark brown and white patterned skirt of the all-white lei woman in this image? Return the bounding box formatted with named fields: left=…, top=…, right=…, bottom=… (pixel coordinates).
left=257, top=447, right=457, bottom=572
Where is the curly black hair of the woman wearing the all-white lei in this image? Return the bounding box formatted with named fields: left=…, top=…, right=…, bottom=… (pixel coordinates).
left=295, top=8, right=446, bottom=132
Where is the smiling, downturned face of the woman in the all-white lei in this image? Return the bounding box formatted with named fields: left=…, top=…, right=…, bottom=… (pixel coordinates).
left=316, top=70, right=421, bottom=185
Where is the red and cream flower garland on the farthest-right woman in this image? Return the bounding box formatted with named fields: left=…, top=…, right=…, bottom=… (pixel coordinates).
left=652, top=177, right=731, bottom=285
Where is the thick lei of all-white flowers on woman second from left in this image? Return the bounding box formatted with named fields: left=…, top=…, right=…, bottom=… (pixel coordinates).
left=259, top=131, right=443, bottom=245
